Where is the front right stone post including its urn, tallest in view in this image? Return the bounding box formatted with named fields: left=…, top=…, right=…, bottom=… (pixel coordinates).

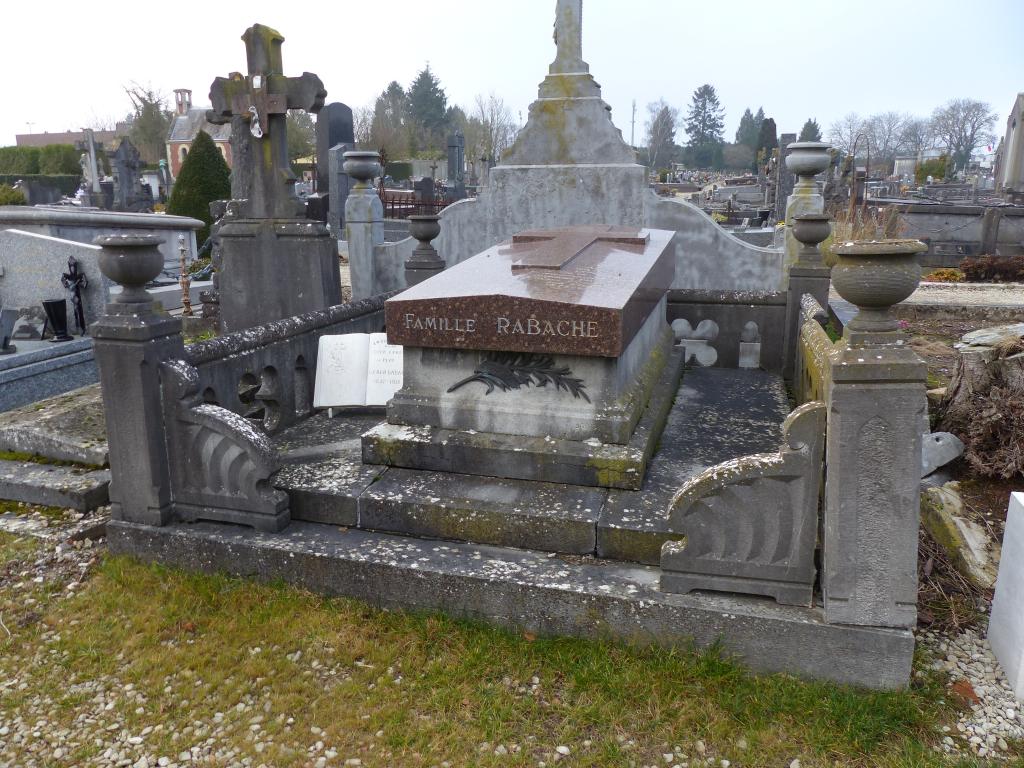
left=821, top=241, right=927, bottom=628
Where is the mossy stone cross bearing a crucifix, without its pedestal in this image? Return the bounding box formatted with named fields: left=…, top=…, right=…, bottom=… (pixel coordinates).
left=207, top=24, right=327, bottom=218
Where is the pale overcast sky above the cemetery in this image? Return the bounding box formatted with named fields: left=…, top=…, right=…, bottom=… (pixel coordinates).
left=0, top=0, right=1024, bottom=145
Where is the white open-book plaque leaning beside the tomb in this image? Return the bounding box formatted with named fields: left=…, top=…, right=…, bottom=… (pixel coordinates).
left=313, top=334, right=402, bottom=408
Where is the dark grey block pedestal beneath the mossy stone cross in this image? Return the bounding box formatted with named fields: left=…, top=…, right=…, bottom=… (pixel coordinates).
left=219, top=219, right=341, bottom=333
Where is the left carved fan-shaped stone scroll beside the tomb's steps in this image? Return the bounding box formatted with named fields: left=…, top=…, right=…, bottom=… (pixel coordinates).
left=162, top=360, right=291, bottom=532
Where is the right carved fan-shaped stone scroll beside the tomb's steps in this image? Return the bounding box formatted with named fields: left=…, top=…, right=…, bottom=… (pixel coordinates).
left=662, top=401, right=826, bottom=605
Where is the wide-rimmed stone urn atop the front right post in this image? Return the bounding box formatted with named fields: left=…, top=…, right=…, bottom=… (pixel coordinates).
left=831, top=240, right=928, bottom=341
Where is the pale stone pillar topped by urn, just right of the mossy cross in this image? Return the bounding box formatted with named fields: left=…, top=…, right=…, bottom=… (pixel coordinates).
left=343, top=152, right=384, bottom=301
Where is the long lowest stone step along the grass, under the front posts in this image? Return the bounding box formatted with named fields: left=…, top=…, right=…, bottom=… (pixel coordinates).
left=106, top=520, right=913, bottom=688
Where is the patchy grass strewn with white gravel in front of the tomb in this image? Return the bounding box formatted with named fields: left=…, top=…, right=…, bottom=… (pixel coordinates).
left=0, top=536, right=1007, bottom=768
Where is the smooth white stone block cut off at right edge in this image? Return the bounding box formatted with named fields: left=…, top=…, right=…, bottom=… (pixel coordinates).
left=988, top=493, right=1024, bottom=701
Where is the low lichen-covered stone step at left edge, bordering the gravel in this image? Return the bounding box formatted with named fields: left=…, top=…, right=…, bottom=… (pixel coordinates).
left=0, top=460, right=111, bottom=512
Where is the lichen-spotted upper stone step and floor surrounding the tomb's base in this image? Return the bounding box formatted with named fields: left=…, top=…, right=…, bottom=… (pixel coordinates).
left=274, top=368, right=790, bottom=565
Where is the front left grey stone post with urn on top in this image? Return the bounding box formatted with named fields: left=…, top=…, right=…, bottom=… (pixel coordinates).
left=91, top=234, right=184, bottom=525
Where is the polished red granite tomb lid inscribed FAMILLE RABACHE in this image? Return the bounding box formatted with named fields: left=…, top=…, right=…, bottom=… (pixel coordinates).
left=385, top=226, right=675, bottom=357
